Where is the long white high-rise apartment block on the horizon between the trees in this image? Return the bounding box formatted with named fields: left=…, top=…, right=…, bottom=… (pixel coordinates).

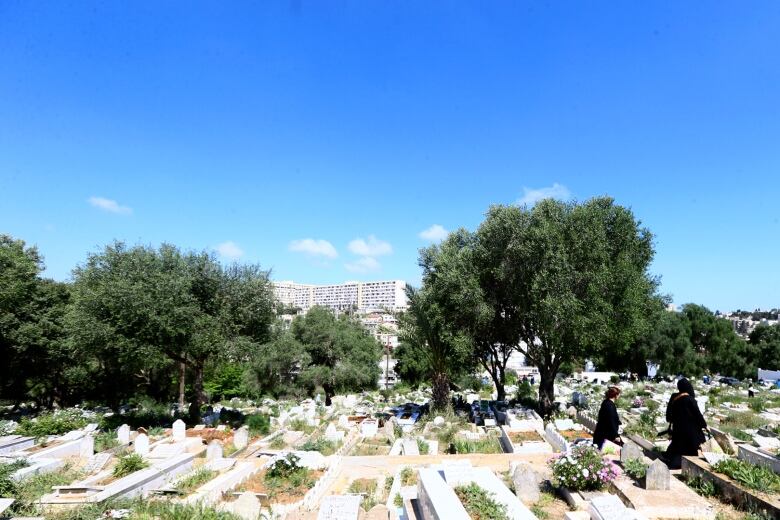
left=273, top=280, right=407, bottom=313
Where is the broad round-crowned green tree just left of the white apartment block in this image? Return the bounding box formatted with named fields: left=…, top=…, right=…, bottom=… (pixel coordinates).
left=72, top=242, right=273, bottom=419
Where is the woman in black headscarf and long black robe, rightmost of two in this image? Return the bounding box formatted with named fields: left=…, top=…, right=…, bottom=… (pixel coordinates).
left=665, top=378, right=707, bottom=469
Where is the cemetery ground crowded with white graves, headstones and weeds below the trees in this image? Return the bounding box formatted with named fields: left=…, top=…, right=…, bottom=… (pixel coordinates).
left=0, top=373, right=780, bottom=520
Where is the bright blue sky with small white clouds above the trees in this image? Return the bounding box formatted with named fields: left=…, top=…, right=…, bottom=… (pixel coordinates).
left=0, top=0, right=780, bottom=310
